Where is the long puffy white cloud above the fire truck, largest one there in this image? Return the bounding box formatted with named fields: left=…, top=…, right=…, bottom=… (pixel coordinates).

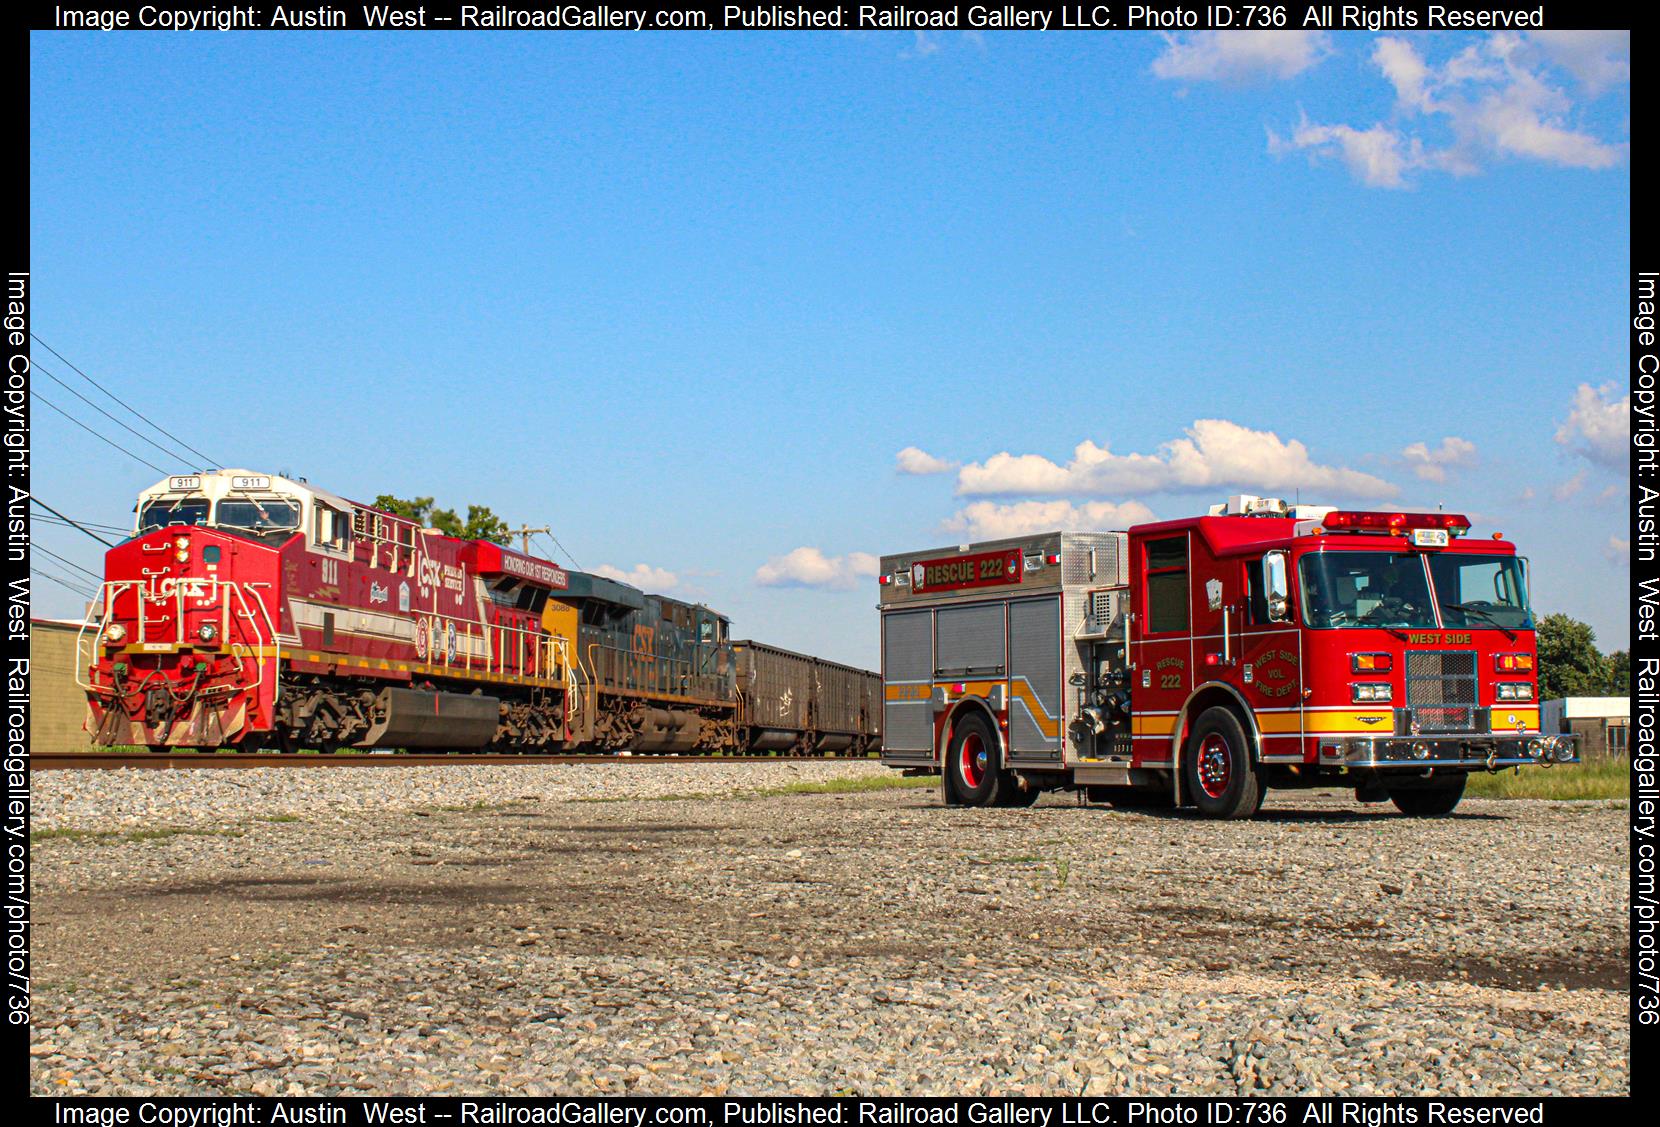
left=956, top=418, right=1399, bottom=498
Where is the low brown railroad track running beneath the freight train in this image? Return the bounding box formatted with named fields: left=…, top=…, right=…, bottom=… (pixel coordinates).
left=28, top=752, right=876, bottom=770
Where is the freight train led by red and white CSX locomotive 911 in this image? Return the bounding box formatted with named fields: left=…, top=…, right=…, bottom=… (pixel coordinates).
left=78, top=470, right=881, bottom=754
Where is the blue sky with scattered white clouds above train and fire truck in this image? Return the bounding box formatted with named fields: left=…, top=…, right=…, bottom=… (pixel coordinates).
left=30, top=33, right=1630, bottom=666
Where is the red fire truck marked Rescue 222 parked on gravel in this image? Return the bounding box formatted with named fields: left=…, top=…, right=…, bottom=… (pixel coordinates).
left=880, top=496, right=1577, bottom=818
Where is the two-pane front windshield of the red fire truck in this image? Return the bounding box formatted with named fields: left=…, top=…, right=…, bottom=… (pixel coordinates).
left=1300, top=551, right=1534, bottom=631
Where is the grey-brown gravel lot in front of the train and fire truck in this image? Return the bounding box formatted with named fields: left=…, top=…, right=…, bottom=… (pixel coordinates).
left=32, top=762, right=1630, bottom=1095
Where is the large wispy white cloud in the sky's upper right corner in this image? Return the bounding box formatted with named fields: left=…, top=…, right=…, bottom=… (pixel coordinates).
left=1268, top=33, right=1630, bottom=188
